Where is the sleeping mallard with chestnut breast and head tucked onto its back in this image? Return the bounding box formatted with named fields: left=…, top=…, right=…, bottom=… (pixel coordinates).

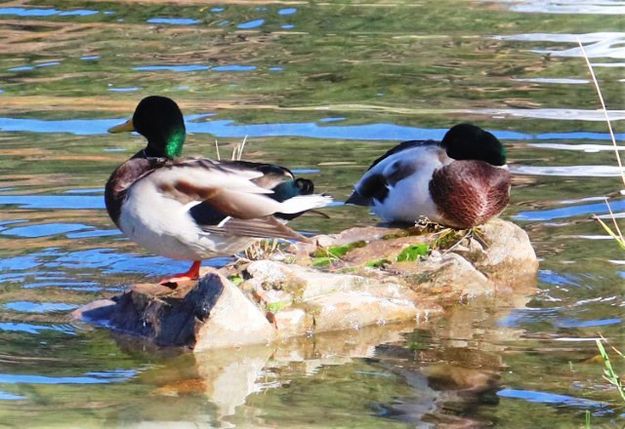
left=346, top=124, right=510, bottom=229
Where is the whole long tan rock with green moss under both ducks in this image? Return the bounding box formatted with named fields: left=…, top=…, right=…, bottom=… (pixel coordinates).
left=74, top=220, right=538, bottom=351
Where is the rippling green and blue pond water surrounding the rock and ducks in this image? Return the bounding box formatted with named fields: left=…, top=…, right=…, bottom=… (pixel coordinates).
left=0, top=0, right=625, bottom=428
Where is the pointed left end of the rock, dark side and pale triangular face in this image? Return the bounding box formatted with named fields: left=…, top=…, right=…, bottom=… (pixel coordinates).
left=74, top=271, right=275, bottom=351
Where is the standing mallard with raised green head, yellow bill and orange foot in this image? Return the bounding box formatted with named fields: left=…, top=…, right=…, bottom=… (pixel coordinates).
left=104, top=96, right=331, bottom=284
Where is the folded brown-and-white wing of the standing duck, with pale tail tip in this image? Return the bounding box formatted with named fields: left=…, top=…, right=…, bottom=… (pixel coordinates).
left=140, top=158, right=331, bottom=240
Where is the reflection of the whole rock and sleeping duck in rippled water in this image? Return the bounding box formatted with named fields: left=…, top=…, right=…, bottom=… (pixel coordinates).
left=111, top=272, right=535, bottom=427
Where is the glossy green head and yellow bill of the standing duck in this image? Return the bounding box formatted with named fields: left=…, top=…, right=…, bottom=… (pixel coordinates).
left=109, top=95, right=186, bottom=159
